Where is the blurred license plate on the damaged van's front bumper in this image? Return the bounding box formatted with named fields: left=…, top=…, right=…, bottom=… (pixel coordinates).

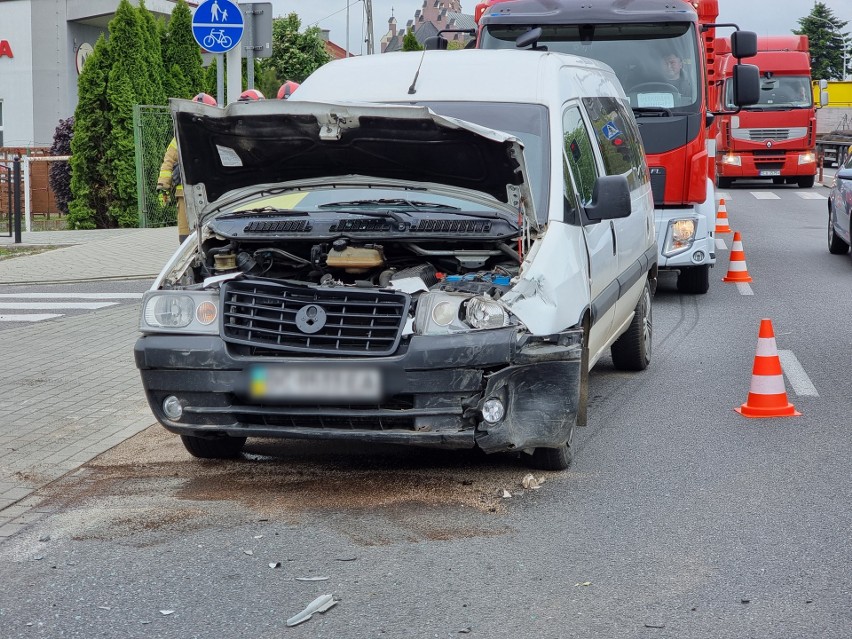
left=249, top=366, right=382, bottom=403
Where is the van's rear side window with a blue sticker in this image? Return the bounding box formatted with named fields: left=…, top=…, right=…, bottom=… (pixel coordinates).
left=583, top=98, right=648, bottom=189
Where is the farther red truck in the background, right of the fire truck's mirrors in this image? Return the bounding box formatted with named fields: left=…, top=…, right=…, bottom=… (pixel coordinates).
left=716, top=35, right=817, bottom=188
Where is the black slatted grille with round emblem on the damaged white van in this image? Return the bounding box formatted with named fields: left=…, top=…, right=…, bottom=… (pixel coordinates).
left=222, top=280, right=411, bottom=356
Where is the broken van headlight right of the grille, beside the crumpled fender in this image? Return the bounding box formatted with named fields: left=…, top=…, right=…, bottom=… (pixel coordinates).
left=414, top=292, right=518, bottom=335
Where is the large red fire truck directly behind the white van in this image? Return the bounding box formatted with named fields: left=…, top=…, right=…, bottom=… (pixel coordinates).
left=475, top=0, right=758, bottom=293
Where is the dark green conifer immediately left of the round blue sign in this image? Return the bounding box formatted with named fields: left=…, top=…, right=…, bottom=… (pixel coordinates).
left=162, top=0, right=204, bottom=98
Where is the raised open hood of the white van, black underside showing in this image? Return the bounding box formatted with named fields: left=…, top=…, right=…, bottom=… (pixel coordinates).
left=170, top=99, right=537, bottom=226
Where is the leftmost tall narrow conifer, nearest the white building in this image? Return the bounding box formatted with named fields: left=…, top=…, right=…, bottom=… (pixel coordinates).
left=68, top=35, right=112, bottom=229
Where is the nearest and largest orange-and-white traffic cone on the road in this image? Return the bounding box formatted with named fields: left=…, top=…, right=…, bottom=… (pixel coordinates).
left=734, top=319, right=801, bottom=417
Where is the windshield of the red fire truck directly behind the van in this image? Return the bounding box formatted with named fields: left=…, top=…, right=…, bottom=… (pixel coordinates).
left=480, top=22, right=702, bottom=116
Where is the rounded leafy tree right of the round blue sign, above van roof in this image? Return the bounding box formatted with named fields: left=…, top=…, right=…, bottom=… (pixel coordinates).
left=261, top=13, right=331, bottom=84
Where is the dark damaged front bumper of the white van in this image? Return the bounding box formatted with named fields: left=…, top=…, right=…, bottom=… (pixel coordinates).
left=135, top=327, right=583, bottom=453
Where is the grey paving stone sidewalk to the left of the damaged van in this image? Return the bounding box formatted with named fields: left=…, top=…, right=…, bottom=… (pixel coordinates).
left=0, top=227, right=177, bottom=542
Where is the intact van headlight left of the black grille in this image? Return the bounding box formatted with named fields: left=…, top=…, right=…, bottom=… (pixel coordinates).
left=139, top=291, right=219, bottom=335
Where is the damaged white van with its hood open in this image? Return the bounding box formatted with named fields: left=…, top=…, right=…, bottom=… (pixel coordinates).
left=135, top=51, right=657, bottom=469
